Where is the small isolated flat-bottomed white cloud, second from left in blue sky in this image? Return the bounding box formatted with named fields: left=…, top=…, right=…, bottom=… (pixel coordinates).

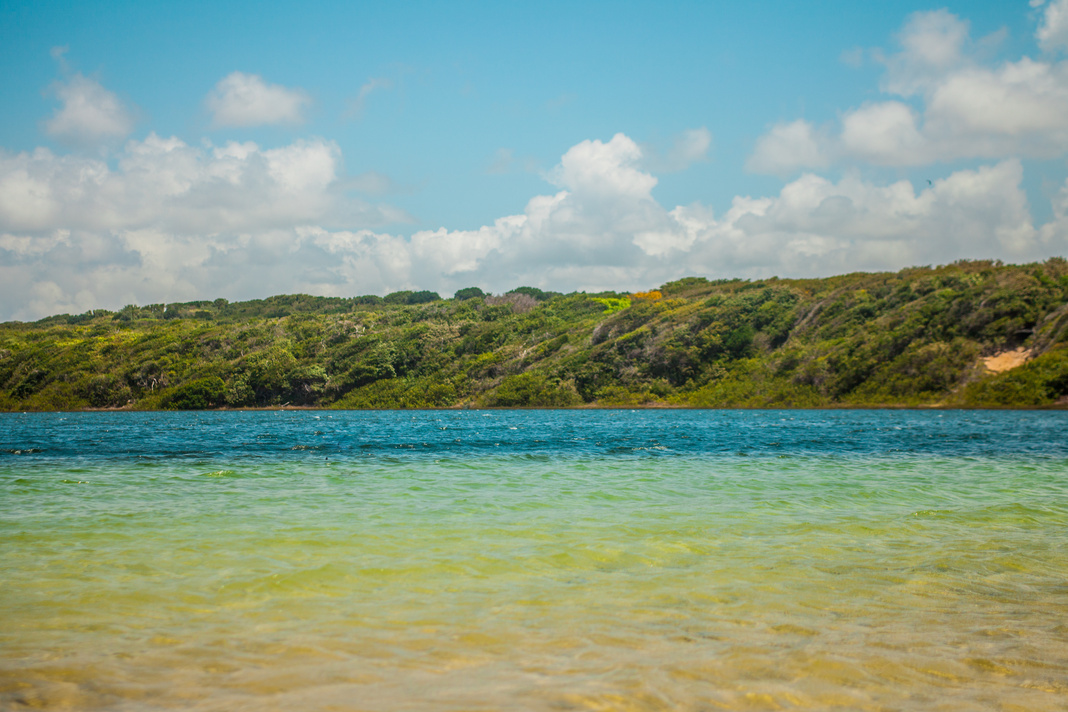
left=205, top=72, right=311, bottom=127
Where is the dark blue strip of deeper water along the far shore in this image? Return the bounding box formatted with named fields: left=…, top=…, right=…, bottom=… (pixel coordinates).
left=0, top=410, right=1068, bottom=466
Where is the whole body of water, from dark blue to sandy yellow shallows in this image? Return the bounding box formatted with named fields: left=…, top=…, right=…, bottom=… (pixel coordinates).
left=0, top=411, right=1068, bottom=711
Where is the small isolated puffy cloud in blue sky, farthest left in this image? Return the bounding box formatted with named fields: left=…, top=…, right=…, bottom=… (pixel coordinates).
left=45, top=73, right=134, bottom=147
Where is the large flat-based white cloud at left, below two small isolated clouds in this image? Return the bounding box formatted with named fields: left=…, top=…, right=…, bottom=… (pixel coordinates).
left=0, top=133, right=406, bottom=236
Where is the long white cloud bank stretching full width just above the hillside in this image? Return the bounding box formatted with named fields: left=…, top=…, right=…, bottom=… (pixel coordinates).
left=0, top=133, right=1068, bottom=318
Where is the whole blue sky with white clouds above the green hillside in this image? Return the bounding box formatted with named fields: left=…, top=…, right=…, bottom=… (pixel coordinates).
left=0, top=0, right=1068, bottom=320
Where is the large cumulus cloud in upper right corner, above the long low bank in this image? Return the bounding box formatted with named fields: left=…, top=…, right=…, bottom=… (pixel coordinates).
left=748, top=6, right=1068, bottom=169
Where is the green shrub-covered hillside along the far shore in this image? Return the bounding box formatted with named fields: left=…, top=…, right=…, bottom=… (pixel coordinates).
left=0, top=258, right=1068, bottom=410
